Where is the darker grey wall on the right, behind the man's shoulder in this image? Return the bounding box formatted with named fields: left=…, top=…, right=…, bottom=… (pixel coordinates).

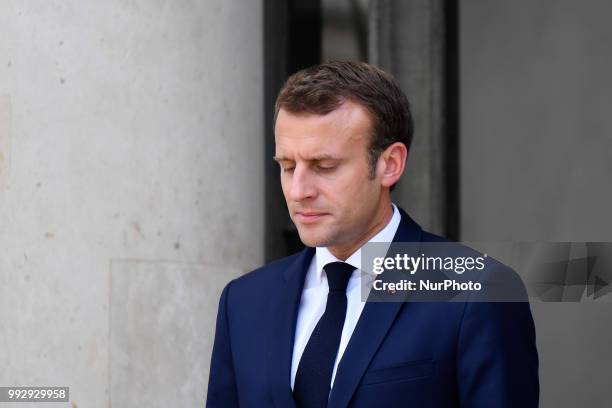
left=460, top=0, right=612, bottom=408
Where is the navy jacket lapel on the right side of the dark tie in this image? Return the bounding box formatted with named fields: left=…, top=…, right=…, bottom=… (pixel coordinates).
left=328, top=209, right=422, bottom=408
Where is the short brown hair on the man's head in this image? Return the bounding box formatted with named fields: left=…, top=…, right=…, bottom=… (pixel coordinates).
left=274, top=61, right=413, bottom=177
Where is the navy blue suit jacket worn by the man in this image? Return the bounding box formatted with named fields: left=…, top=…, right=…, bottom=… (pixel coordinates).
left=207, top=210, right=539, bottom=408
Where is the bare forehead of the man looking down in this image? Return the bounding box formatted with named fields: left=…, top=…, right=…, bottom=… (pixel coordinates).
left=274, top=101, right=372, bottom=158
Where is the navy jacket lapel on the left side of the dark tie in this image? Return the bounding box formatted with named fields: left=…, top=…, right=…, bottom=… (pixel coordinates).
left=267, top=248, right=315, bottom=408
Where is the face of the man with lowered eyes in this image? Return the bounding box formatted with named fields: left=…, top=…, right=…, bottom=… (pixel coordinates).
left=275, top=102, right=390, bottom=252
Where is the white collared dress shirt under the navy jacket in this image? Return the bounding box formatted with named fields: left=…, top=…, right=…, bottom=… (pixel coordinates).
left=291, top=204, right=401, bottom=389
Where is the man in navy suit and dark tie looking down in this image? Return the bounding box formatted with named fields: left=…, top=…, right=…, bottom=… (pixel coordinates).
left=207, top=62, right=538, bottom=408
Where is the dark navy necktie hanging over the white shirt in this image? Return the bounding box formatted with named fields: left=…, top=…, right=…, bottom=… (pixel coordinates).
left=293, top=262, right=355, bottom=408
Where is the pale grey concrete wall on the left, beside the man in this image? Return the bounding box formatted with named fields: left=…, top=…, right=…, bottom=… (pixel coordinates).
left=0, top=0, right=263, bottom=407
